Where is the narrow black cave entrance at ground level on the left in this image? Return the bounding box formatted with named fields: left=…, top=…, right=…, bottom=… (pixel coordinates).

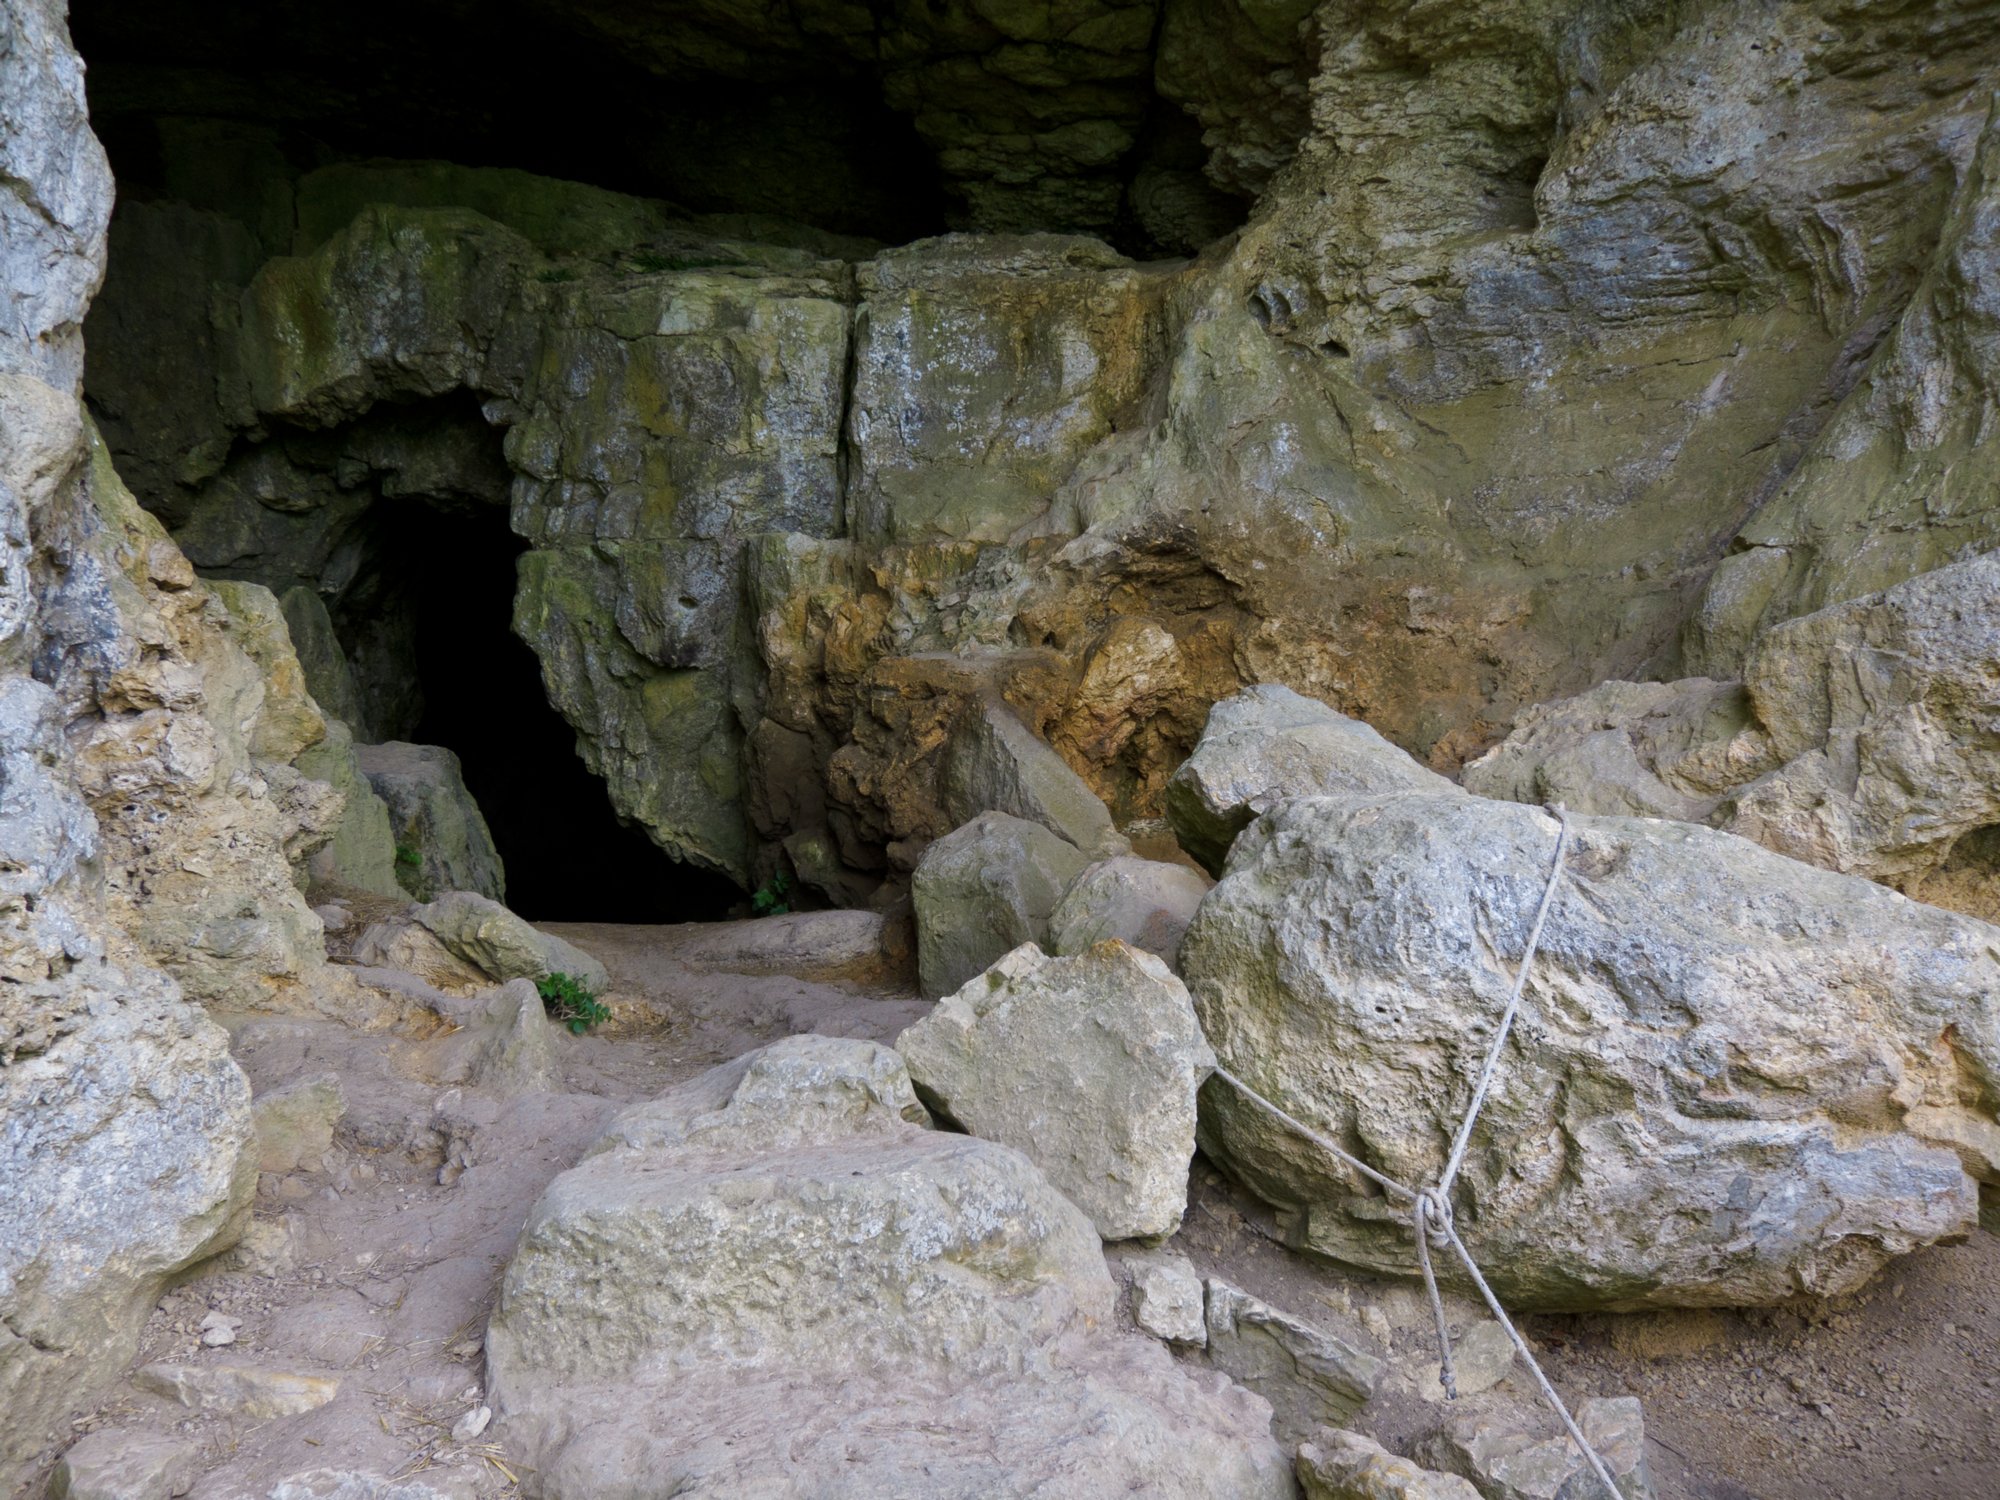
left=378, top=502, right=742, bottom=922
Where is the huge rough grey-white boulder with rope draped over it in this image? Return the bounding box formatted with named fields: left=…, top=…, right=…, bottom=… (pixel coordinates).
left=1182, top=794, right=2000, bottom=1308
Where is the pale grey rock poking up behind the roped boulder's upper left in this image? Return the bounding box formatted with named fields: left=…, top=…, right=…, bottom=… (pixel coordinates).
left=1166, top=682, right=1454, bottom=876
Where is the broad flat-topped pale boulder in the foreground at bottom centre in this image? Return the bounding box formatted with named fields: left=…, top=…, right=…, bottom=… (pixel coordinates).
left=486, top=1036, right=1290, bottom=1500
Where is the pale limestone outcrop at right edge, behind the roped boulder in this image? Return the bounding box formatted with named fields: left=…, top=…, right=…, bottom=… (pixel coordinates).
left=1464, top=552, right=2000, bottom=916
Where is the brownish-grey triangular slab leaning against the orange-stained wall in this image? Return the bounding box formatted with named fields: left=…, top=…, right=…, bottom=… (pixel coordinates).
left=942, top=700, right=1132, bottom=858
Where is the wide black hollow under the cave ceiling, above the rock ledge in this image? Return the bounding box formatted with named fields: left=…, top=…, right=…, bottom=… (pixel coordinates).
left=70, top=0, right=946, bottom=242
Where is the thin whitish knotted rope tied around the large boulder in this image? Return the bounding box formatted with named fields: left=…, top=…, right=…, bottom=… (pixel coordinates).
left=1214, top=802, right=1620, bottom=1500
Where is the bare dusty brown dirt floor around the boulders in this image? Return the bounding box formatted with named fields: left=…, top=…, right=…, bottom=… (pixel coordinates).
left=23, top=924, right=2000, bottom=1500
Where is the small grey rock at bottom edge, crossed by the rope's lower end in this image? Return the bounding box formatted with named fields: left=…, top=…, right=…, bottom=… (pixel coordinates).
left=1416, top=1396, right=1652, bottom=1500
